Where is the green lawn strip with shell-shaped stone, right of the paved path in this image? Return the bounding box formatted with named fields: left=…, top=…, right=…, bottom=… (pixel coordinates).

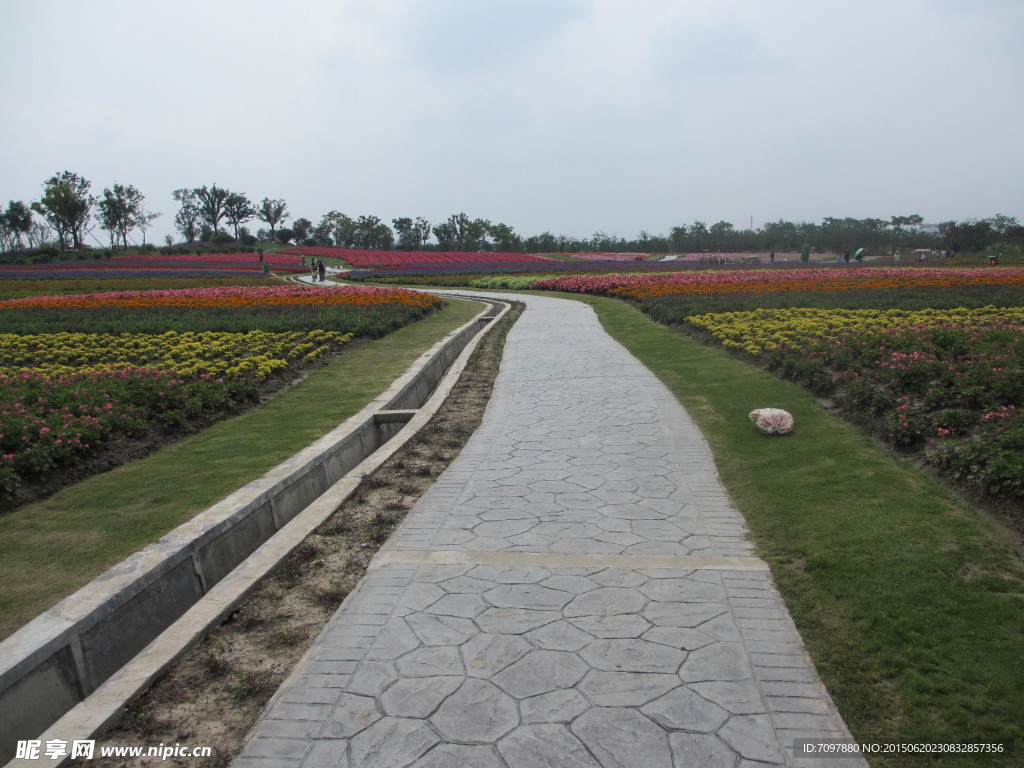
left=540, top=292, right=1024, bottom=766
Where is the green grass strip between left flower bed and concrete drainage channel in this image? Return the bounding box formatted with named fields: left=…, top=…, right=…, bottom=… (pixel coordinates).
left=0, top=301, right=481, bottom=639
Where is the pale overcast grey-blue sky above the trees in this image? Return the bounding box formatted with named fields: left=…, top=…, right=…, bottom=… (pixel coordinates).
left=0, top=0, right=1024, bottom=242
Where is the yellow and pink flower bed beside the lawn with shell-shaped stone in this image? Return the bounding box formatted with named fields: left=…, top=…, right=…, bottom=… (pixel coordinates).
left=687, top=306, right=1024, bottom=500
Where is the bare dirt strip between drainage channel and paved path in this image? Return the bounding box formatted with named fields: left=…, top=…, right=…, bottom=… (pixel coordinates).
left=77, top=304, right=523, bottom=768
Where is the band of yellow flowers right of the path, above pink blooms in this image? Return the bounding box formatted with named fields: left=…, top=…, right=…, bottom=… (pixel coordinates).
left=687, top=307, right=1024, bottom=354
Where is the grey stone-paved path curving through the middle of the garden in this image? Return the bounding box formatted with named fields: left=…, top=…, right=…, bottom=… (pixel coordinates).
left=234, top=296, right=865, bottom=768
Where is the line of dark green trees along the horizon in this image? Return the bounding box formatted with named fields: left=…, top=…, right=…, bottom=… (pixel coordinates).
left=0, top=171, right=1024, bottom=253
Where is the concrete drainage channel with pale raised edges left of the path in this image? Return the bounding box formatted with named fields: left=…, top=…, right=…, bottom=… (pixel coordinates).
left=0, top=297, right=510, bottom=768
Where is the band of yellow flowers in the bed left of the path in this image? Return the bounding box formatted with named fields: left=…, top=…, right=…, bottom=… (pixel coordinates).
left=0, top=330, right=352, bottom=380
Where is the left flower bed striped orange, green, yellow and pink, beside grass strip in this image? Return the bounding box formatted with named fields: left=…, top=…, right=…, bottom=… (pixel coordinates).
left=0, top=286, right=440, bottom=505
